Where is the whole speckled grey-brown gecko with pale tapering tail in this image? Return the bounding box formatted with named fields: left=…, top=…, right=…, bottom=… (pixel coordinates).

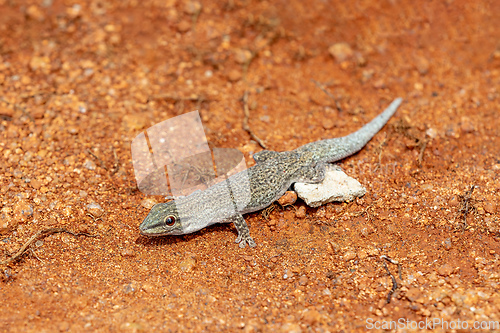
left=139, top=98, right=402, bottom=248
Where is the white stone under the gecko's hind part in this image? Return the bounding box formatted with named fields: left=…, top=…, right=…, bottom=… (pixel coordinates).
left=294, top=164, right=366, bottom=207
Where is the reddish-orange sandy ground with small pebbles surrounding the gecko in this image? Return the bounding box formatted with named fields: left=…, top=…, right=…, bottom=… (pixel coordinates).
left=0, top=0, right=500, bottom=332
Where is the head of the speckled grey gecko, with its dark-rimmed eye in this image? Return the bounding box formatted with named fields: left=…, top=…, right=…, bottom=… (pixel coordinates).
left=139, top=201, right=185, bottom=236
